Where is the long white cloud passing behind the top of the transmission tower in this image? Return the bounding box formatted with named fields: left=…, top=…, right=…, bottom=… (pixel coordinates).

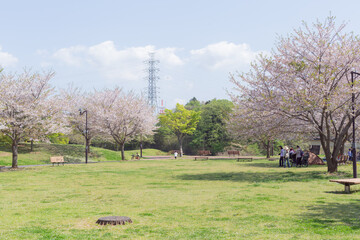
left=53, top=41, right=183, bottom=81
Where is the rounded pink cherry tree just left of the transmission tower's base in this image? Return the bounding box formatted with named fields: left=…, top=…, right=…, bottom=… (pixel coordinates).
left=89, top=88, right=156, bottom=160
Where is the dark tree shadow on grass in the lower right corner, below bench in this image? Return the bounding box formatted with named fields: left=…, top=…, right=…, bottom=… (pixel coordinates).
left=299, top=199, right=360, bottom=230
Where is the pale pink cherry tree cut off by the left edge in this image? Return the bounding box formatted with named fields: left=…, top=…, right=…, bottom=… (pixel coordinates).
left=0, top=70, right=66, bottom=168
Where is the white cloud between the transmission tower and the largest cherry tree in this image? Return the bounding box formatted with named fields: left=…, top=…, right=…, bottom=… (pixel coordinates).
left=190, top=41, right=260, bottom=70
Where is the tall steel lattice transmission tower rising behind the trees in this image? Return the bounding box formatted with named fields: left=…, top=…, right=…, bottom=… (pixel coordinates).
left=147, top=53, right=160, bottom=112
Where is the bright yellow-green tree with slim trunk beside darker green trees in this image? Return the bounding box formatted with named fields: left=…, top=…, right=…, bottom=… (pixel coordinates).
left=159, top=104, right=201, bottom=157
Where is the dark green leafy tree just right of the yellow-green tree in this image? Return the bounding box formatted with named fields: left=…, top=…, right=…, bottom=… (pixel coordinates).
left=191, top=99, right=234, bottom=154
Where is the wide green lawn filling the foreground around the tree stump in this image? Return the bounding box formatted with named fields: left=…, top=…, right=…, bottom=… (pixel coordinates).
left=0, top=159, right=360, bottom=240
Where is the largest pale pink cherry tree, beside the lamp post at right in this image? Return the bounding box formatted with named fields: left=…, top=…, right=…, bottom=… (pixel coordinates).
left=231, top=17, right=360, bottom=173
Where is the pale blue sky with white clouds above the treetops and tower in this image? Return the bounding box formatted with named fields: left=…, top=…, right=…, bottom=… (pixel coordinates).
left=0, top=0, right=360, bottom=108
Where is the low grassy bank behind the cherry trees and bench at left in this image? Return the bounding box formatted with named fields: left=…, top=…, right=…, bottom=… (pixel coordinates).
left=0, top=143, right=166, bottom=166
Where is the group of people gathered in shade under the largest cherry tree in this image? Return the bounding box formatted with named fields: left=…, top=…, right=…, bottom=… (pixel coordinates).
left=279, top=146, right=304, bottom=168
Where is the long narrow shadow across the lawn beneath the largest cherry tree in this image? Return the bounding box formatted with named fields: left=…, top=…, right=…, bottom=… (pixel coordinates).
left=176, top=171, right=352, bottom=183
